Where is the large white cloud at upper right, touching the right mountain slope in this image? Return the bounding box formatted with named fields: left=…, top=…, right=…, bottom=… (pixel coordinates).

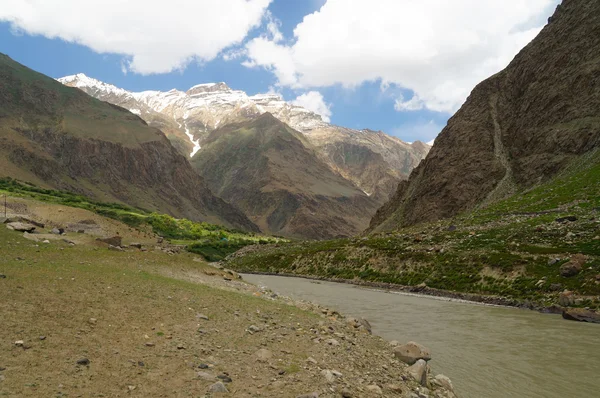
left=244, top=0, right=558, bottom=112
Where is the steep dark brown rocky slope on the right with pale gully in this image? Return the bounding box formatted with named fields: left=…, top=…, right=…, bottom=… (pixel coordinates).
left=370, top=0, right=600, bottom=231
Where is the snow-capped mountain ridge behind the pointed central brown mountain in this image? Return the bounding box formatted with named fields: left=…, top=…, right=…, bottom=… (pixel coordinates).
left=58, top=73, right=430, bottom=201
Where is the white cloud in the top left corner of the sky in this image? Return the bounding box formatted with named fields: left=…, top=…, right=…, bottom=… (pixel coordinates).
left=0, top=0, right=272, bottom=74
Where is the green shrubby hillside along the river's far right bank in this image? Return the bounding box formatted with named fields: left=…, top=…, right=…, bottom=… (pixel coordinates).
left=228, top=150, right=600, bottom=308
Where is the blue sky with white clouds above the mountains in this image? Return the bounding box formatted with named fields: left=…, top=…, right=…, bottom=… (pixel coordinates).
left=0, top=0, right=557, bottom=141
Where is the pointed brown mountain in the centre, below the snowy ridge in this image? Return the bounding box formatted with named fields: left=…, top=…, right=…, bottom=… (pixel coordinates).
left=192, top=113, right=377, bottom=239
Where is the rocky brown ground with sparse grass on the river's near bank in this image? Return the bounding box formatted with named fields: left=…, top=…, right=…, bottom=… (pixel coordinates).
left=0, top=200, right=455, bottom=398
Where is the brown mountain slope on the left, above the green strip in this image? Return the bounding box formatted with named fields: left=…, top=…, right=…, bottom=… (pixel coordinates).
left=0, top=54, right=257, bottom=230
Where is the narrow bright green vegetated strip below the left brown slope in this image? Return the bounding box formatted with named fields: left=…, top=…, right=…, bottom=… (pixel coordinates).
left=0, top=178, right=287, bottom=261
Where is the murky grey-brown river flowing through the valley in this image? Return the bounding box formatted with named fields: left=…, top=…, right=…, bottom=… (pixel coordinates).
left=244, top=275, right=600, bottom=398
